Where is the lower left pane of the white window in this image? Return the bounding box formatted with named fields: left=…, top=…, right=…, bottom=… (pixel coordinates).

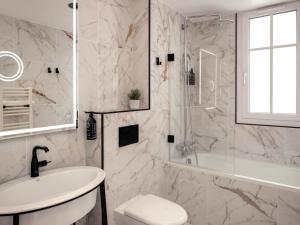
left=250, top=50, right=270, bottom=113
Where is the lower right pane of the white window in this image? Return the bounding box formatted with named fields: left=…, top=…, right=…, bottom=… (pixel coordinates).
left=273, top=47, right=296, bottom=113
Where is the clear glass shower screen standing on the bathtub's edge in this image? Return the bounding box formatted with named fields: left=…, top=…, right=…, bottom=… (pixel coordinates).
left=169, top=16, right=235, bottom=173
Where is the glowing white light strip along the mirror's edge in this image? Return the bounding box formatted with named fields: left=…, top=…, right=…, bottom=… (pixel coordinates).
left=0, top=0, right=78, bottom=140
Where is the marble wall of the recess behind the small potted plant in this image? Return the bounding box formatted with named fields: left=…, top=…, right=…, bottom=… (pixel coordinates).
left=93, top=0, right=149, bottom=112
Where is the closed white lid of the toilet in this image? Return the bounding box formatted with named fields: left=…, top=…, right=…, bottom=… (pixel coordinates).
left=124, top=195, right=187, bottom=225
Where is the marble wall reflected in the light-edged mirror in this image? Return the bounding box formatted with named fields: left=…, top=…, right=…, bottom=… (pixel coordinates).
left=0, top=15, right=73, bottom=127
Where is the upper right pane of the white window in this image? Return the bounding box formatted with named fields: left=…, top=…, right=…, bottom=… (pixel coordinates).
left=273, top=11, right=297, bottom=46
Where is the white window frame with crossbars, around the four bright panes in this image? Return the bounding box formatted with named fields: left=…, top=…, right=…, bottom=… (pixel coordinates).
left=236, top=2, right=300, bottom=127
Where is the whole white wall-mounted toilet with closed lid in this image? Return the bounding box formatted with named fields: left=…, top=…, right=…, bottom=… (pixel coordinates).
left=114, top=195, right=188, bottom=225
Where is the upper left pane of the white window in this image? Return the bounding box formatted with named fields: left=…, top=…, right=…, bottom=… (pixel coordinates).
left=250, top=16, right=271, bottom=49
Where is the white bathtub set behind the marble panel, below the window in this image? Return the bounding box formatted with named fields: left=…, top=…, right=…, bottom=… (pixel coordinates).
left=172, top=153, right=300, bottom=192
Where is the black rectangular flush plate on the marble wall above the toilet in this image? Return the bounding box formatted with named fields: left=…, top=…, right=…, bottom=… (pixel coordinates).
left=119, top=125, right=139, bottom=147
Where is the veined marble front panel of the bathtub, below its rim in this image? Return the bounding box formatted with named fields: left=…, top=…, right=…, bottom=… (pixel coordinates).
left=166, top=164, right=300, bottom=225
